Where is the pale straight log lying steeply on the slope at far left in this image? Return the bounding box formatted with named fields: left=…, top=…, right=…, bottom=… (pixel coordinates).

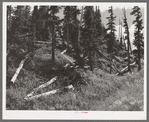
left=11, top=55, right=28, bottom=83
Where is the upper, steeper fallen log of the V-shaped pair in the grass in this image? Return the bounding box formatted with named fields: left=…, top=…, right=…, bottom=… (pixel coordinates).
left=27, top=77, right=57, bottom=97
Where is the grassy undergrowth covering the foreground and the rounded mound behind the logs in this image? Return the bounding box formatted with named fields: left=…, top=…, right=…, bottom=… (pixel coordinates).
left=6, top=45, right=144, bottom=111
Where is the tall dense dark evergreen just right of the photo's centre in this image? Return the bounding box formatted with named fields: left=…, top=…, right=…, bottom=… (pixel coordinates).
left=82, top=6, right=95, bottom=70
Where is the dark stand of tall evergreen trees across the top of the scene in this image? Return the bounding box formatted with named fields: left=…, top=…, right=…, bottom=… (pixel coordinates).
left=7, top=6, right=144, bottom=73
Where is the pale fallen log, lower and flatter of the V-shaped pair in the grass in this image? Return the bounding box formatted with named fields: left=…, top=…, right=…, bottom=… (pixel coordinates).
left=24, top=85, right=74, bottom=100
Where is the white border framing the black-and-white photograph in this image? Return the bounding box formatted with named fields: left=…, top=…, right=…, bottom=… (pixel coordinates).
left=2, top=2, right=147, bottom=120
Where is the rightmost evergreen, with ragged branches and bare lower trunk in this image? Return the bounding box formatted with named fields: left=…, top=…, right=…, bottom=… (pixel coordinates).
left=131, top=6, right=144, bottom=71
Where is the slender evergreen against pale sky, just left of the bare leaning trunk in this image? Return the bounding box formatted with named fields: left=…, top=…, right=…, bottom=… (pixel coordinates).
left=107, top=6, right=116, bottom=74
